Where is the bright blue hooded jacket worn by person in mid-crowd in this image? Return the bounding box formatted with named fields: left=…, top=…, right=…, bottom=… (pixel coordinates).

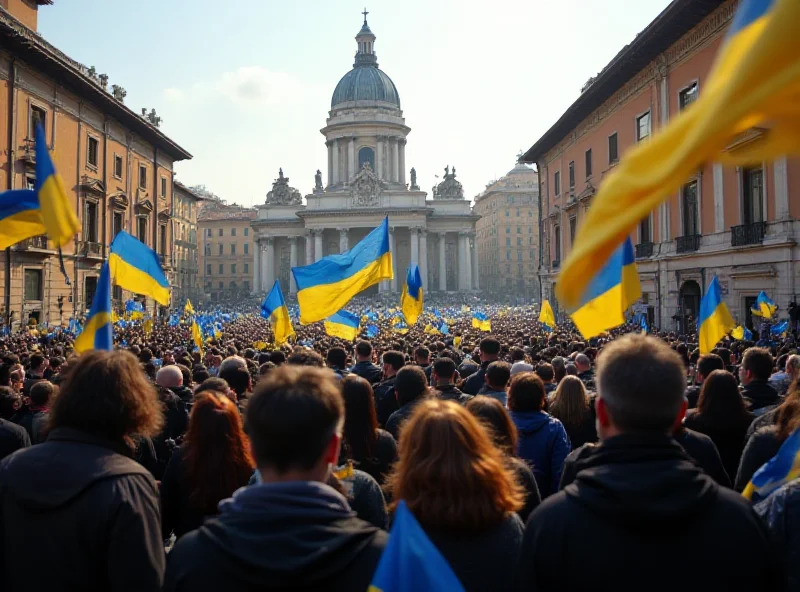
left=511, top=411, right=572, bottom=499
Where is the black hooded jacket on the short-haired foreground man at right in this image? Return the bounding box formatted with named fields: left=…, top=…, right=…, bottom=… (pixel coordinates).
left=517, top=435, right=783, bottom=592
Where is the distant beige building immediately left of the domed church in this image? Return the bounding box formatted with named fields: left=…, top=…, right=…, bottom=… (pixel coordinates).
left=197, top=199, right=256, bottom=304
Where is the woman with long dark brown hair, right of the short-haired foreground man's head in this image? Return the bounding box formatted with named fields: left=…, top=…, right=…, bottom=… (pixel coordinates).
left=684, top=370, right=754, bottom=477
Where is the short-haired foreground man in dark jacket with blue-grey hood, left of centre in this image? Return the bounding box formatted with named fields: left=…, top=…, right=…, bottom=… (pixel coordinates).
left=164, top=366, right=388, bottom=592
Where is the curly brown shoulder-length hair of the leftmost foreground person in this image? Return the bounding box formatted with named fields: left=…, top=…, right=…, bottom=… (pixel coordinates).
left=49, top=350, right=164, bottom=442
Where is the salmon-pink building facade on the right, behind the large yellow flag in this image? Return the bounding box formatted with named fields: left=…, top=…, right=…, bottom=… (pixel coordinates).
left=538, top=0, right=800, bottom=329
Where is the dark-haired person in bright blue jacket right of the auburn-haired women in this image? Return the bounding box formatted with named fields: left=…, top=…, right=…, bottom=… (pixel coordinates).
left=508, top=372, right=572, bottom=499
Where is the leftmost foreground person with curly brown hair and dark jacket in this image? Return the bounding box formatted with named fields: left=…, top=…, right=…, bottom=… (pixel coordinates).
left=0, top=351, right=165, bottom=590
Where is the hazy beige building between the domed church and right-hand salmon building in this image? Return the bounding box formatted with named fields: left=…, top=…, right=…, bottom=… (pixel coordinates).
left=473, top=164, right=540, bottom=301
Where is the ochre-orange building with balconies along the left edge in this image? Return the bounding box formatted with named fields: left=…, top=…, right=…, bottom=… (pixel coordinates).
left=0, top=0, right=191, bottom=328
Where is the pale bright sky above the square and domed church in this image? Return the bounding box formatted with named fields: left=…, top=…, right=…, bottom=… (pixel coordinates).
left=39, top=0, right=668, bottom=205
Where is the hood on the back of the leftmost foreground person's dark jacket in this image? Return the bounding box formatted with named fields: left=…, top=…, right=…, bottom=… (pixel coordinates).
left=0, top=428, right=146, bottom=511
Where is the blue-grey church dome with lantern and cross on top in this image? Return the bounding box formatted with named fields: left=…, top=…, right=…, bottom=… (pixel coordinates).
left=331, top=11, right=400, bottom=109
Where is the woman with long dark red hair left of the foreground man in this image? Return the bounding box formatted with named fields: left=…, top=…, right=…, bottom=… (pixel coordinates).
left=161, top=391, right=255, bottom=538
